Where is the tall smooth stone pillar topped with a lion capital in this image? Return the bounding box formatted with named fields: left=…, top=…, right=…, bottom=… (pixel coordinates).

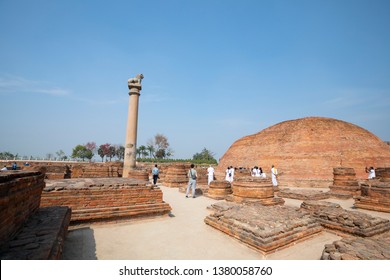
left=122, top=74, right=144, bottom=178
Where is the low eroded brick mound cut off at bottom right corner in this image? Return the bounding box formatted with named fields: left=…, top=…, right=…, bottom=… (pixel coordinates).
left=321, top=232, right=390, bottom=260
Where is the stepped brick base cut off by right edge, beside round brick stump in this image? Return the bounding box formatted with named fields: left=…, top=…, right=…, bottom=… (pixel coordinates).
left=354, top=180, right=390, bottom=212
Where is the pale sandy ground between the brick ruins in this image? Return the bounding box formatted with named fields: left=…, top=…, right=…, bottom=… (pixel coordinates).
left=63, top=186, right=390, bottom=260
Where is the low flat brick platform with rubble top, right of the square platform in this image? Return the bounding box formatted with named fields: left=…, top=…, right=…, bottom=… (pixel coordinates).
left=301, top=201, right=390, bottom=237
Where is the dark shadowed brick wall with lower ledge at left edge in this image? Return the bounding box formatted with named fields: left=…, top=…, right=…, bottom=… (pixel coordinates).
left=0, top=171, right=71, bottom=260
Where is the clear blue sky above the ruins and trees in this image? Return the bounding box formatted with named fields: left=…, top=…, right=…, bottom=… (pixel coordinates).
left=0, top=0, right=390, bottom=159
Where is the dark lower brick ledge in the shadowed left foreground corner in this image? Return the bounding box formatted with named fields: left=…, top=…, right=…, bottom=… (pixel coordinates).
left=0, top=207, right=71, bottom=260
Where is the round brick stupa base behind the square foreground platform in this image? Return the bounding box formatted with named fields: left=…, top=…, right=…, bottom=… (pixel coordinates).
left=232, top=176, right=284, bottom=205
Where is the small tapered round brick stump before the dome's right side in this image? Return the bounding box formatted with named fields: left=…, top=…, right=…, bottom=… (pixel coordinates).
left=329, top=167, right=360, bottom=199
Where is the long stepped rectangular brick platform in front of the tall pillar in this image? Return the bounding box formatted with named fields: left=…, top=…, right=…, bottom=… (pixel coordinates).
left=41, top=178, right=171, bottom=222
